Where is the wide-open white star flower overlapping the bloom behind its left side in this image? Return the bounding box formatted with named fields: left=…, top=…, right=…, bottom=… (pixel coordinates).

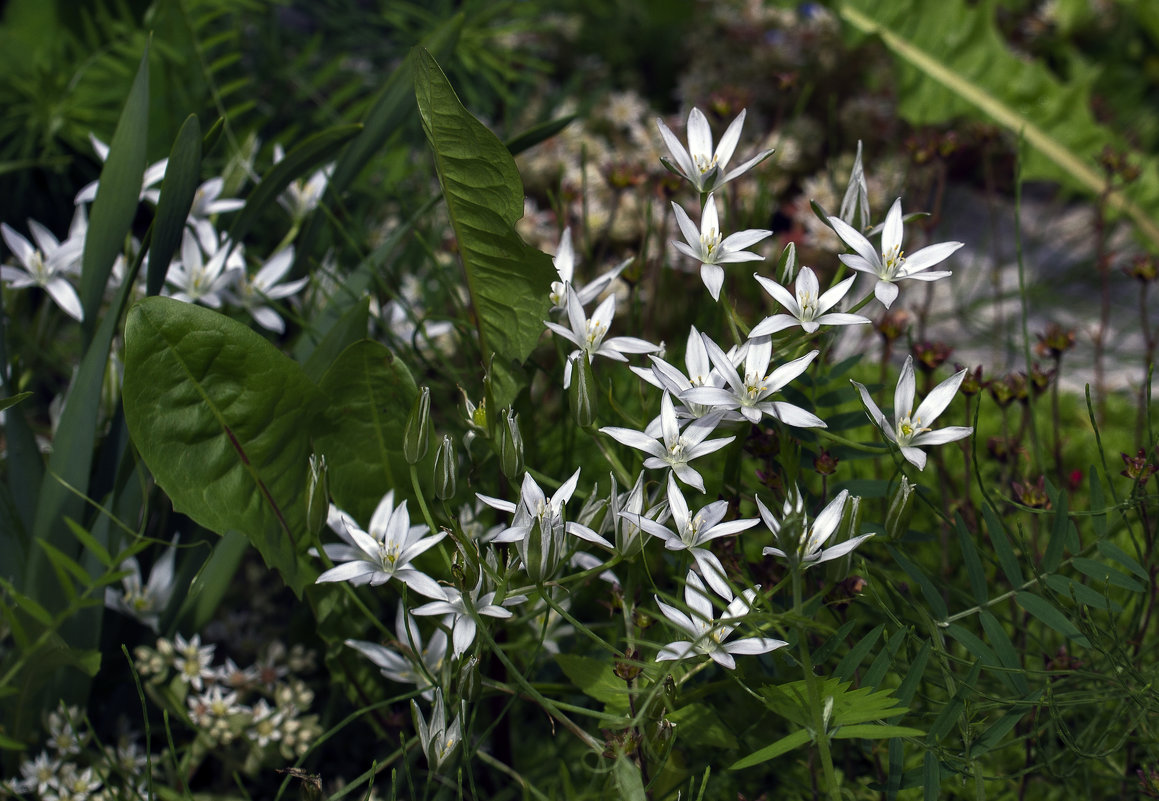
left=680, top=335, right=828, bottom=428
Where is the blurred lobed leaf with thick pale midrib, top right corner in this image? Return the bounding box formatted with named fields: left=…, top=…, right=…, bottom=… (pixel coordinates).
left=838, top=0, right=1159, bottom=243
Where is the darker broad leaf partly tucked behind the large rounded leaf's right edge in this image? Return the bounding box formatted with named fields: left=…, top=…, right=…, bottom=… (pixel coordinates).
left=315, top=340, right=418, bottom=524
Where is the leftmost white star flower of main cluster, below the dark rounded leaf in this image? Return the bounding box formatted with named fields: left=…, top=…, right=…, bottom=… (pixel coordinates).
left=315, top=489, right=446, bottom=598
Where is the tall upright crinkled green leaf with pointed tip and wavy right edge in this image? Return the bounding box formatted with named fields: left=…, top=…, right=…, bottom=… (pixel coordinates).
left=415, top=51, right=555, bottom=408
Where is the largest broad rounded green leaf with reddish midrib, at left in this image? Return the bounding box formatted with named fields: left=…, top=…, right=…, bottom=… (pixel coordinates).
left=123, top=298, right=325, bottom=594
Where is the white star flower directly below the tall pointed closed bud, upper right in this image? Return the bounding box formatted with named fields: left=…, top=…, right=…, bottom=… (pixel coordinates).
left=829, top=198, right=963, bottom=308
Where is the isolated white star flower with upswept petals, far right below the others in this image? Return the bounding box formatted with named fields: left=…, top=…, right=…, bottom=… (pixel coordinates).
left=852, top=356, right=974, bottom=469
